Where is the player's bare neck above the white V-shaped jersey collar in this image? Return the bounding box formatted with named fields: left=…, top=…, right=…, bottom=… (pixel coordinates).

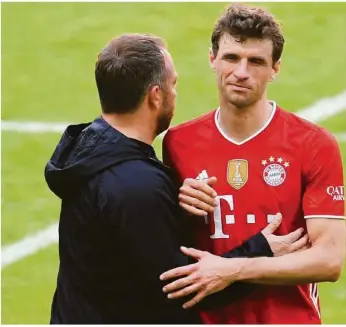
left=218, top=97, right=273, bottom=142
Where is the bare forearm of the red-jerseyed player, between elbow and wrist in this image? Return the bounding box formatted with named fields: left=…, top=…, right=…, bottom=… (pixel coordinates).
left=236, top=246, right=340, bottom=285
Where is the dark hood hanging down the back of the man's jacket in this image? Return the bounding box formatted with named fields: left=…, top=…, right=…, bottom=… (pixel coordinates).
left=45, top=117, right=157, bottom=198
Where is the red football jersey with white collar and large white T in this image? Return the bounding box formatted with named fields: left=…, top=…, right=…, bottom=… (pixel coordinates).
left=163, top=102, right=344, bottom=324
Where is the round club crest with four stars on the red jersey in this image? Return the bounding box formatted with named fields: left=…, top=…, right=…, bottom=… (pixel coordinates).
left=262, top=157, right=289, bottom=186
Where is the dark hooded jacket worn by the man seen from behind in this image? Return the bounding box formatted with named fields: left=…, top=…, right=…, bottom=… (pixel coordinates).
left=45, top=117, right=271, bottom=324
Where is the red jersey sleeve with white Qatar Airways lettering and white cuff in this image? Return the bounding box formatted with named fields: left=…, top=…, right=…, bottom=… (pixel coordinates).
left=303, top=131, right=345, bottom=219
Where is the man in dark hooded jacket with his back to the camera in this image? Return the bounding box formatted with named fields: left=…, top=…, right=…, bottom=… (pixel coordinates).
left=45, top=34, right=302, bottom=324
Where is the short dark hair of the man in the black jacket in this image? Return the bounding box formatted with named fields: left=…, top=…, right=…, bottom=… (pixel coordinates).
left=95, top=34, right=166, bottom=114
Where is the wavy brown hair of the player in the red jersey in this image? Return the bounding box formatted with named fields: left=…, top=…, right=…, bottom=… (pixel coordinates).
left=211, top=4, right=285, bottom=63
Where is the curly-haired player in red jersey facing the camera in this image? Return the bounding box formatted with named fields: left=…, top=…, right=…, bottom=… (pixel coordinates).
left=161, top=5, right=345, bottom=324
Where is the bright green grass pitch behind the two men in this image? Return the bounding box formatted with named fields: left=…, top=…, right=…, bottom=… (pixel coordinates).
left=1, top=3, right=346, bottom=324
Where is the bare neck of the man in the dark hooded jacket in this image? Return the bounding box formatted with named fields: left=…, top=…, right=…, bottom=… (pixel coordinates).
left=102, top=109, right=155, bottom=145
